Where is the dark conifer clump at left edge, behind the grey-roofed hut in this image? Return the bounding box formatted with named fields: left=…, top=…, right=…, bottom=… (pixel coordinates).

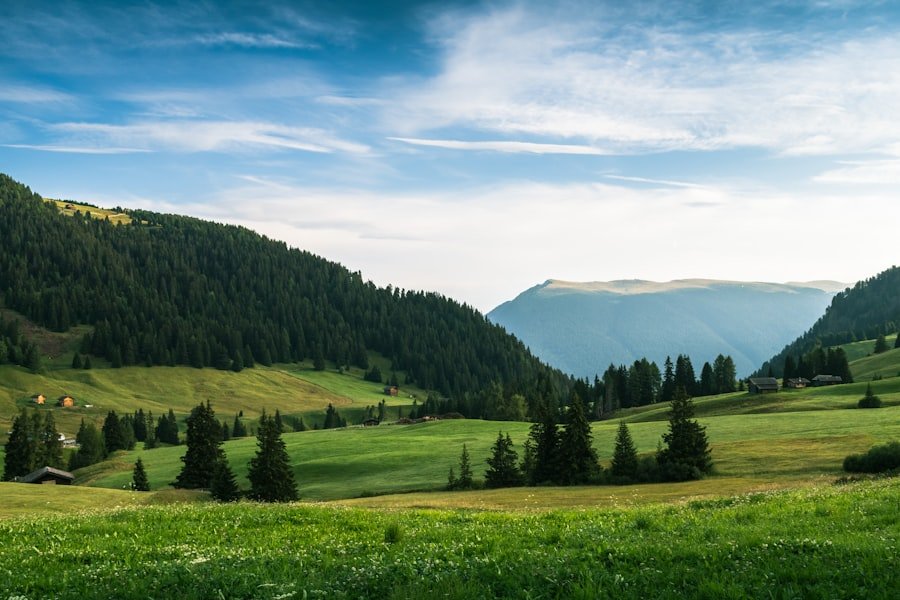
left=3, top=409, right=65, bottom=481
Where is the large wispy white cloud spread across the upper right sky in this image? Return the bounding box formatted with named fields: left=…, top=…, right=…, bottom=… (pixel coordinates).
left=387, top=5, right=900, bottom=155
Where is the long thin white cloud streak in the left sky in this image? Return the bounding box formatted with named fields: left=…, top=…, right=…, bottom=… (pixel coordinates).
left=48, top=120, right=369, bottom=154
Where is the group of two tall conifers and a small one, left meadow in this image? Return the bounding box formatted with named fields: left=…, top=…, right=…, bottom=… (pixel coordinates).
left=173, top=401, right=298, bottom=502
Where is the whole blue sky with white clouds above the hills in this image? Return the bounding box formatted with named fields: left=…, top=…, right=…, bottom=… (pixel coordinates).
left=0, top=0, right=900, bottom=312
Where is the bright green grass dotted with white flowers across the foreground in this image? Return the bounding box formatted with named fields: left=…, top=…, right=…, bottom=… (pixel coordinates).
left=0, top=480, right=900, bottom=599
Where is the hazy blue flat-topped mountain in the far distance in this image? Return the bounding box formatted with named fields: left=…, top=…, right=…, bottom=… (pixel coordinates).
left=488, top=279, right=845, bottom=377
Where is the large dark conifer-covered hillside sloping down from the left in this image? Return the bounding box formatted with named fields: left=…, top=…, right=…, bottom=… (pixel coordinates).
left=0, top=175, right=569, bottom=398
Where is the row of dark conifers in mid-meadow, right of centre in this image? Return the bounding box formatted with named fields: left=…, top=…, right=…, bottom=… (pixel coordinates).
left=447, top=386, right=712, bottom=490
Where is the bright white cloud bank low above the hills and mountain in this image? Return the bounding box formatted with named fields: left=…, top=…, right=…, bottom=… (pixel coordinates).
left=118, top=177, right=896, bottom=311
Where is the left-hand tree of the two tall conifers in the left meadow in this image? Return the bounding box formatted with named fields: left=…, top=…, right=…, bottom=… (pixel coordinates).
left=172, top=400, right=222, bottom=489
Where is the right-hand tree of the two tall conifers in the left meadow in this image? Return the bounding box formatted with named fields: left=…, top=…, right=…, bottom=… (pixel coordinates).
left=247, top=413, right=298, bottom=502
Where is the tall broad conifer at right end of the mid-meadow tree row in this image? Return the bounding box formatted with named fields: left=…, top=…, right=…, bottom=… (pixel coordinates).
left=656, top=386, right=712, bottom=481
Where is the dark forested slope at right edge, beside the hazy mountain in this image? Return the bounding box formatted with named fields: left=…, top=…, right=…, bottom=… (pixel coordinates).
left=757, top=267, right=900, bottom=377
